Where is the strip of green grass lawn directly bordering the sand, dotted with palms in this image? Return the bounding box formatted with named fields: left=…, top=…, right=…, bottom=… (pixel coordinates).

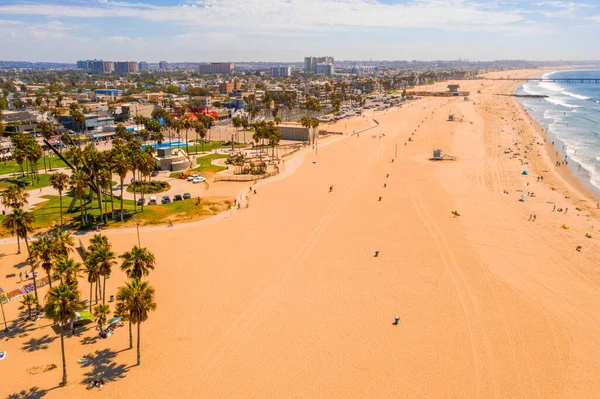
left=0, top=195, right=231, bottom=236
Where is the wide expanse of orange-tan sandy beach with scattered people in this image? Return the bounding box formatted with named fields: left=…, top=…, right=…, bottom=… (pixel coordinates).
left=0, top=70, right=600, bottom=398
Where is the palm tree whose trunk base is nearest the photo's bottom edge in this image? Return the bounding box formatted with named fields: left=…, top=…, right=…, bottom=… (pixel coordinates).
left=44, top=284, right=80, bottom=386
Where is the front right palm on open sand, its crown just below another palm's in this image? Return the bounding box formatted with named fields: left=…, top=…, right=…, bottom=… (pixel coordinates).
left=117, top=278, right=156, bottom=365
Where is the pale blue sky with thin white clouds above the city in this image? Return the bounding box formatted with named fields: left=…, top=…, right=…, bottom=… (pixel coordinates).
left=0, top=0, right=600, bottom=62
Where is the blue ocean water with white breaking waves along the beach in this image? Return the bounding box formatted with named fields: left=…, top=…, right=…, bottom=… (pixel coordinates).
left=515, top=67, right=600, bottom=195
